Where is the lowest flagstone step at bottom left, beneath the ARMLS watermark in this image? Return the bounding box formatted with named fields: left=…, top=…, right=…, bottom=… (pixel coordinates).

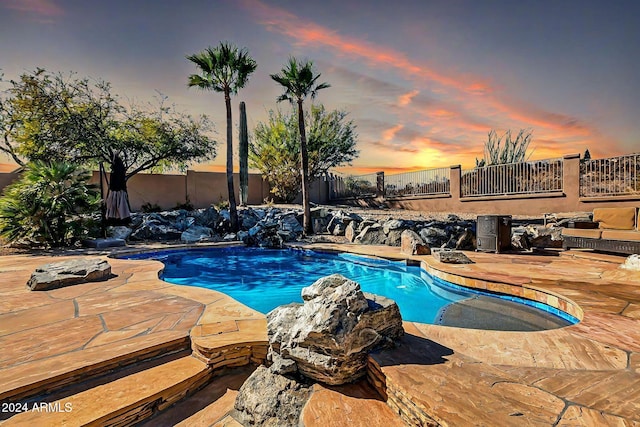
left=5, top=356, right=212, bottom=427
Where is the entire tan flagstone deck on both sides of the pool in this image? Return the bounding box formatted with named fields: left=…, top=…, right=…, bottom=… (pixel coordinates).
left=0, top=244, right=640, bottom=426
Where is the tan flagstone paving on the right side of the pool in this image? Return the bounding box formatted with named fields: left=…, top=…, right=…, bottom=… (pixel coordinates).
left=302, top=244, right=640, bottom=426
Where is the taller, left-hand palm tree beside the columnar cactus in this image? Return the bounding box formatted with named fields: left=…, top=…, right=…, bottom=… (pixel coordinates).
left=187, top=42, right=258, bottom=232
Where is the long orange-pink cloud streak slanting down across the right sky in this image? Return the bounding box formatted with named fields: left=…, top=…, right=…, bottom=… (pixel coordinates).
left=240, top=0, right=611, bottom=168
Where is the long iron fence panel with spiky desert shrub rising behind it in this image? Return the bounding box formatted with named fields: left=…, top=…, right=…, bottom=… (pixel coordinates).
left=460, top=158, right=563, bottom=197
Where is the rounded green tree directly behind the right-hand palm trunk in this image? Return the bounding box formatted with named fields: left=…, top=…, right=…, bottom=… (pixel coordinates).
left=249, top=105, right=358, bottom=202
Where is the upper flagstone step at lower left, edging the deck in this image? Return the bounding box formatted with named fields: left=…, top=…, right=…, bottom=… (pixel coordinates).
left=0, top=331, right=191, bottom=403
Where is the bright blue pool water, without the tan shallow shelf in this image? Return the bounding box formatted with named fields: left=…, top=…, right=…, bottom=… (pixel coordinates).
left=128, top=247, right=576, bottom=326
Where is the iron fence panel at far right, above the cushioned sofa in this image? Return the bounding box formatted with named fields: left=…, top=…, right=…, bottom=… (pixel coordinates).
left=580, top=153, right=640, bottom=197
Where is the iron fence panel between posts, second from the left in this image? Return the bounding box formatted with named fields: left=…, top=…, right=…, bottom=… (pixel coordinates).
left=384, top=168, right=451, bottom=198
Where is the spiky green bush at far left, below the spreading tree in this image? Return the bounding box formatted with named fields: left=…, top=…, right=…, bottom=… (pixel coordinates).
left=0, top=161, right=100, bottom=247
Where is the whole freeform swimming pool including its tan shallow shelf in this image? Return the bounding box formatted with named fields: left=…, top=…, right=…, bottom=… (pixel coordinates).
left=128, top=247, right=577, bottom=330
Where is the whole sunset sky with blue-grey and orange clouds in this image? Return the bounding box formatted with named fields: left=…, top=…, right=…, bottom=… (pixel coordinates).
left=0, top=0, right=640, bottom=174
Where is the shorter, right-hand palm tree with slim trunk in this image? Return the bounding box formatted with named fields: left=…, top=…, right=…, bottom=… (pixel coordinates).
left=271, top=57, right=330, bottom=234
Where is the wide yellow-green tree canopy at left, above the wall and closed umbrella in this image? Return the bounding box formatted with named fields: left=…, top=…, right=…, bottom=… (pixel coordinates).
left=0, top=68, right=216, bottom=180
